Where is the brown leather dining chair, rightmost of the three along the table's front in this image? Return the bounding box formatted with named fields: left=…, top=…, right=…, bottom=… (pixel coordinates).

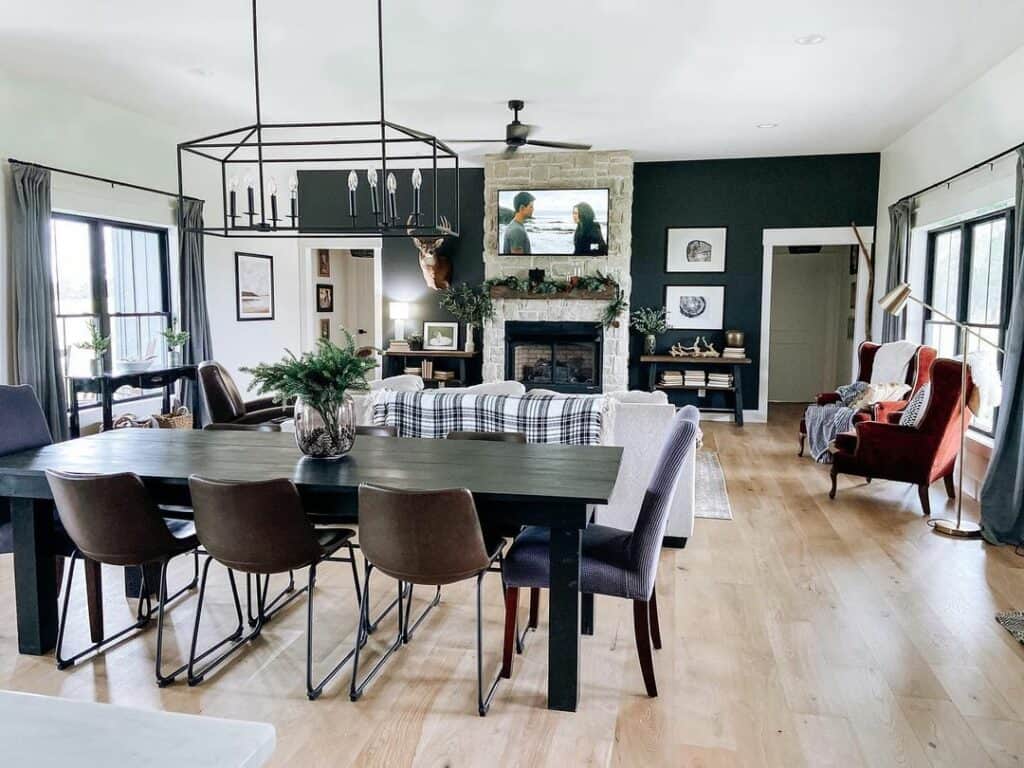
left=349, top=483, right=502, bottom=717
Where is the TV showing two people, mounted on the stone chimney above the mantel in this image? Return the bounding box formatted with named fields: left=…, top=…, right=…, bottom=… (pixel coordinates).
left=498, top=189, right=608, bottom=256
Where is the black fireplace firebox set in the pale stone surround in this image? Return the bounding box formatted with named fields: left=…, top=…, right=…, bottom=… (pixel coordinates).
left=505, top=321, right=604, bottom=393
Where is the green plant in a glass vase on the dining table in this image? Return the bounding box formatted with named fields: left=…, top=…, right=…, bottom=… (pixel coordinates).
left=241, top=328, right=377, bottom=459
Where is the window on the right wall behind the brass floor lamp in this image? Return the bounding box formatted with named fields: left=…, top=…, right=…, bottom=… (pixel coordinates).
left=924, top=209, right=1013, bottom=434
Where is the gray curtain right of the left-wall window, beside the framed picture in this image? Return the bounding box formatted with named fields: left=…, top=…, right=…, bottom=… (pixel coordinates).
left=179, top=199, right=213, bottom=410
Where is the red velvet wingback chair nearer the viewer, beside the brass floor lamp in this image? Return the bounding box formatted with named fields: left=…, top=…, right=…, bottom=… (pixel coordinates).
left=828, top=359, right=974, bottom=516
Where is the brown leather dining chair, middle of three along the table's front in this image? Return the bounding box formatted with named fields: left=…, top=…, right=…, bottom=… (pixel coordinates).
left=187, top=475, right=360, bottom=700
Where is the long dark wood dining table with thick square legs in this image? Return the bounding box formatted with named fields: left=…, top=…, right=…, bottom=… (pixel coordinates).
left=0, top=429, right=622, bottom=712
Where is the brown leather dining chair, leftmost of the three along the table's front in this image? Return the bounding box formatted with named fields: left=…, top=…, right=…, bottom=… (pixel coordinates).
left=46, top=470, right=199, bottom=687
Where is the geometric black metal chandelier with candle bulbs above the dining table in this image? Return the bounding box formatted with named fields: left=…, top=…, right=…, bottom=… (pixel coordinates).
left=178, top=0, right=460, bottom=238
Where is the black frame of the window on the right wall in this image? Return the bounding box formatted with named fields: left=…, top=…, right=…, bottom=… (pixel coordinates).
left=921, top=207, right=1014, bottom=437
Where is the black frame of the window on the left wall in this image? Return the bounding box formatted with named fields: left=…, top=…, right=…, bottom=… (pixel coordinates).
left=51, top=211, right=173, bottom=411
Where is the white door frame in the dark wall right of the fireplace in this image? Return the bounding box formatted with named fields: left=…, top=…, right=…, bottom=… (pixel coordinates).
left=761, top=226, right=874, bottom=422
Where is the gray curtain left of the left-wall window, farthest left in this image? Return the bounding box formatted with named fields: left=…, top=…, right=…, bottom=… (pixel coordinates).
left=10, top=163, right=68, bottom=441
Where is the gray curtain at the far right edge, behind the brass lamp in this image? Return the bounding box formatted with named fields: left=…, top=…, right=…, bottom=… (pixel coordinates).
left=981, top=148, right=1024, bottom=544
